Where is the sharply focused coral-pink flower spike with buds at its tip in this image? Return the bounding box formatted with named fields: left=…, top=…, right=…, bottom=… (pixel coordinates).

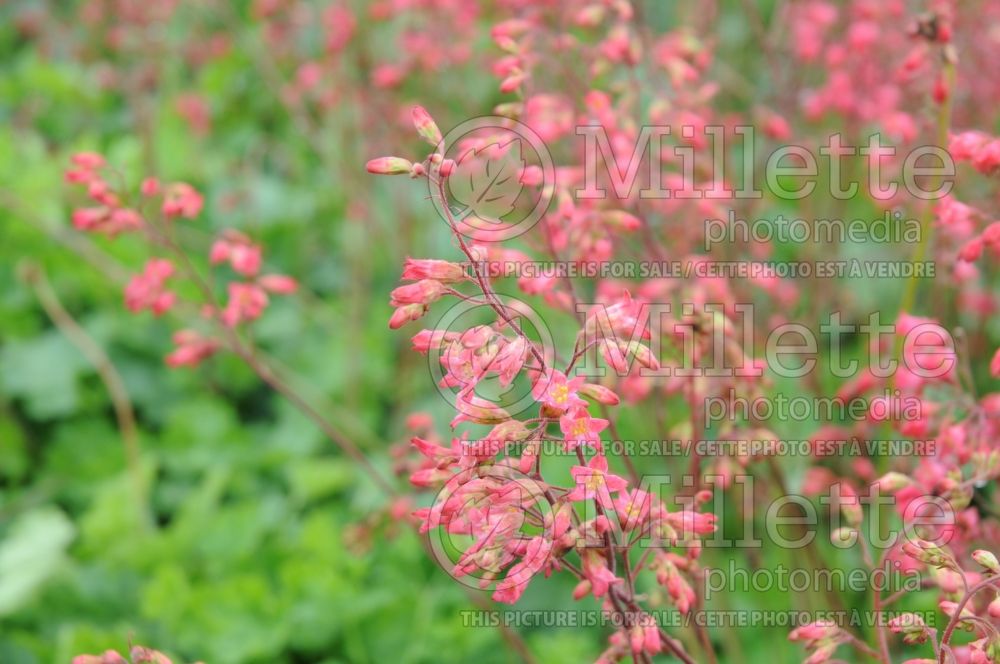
left=368, top=107, right=716, bottom=661
